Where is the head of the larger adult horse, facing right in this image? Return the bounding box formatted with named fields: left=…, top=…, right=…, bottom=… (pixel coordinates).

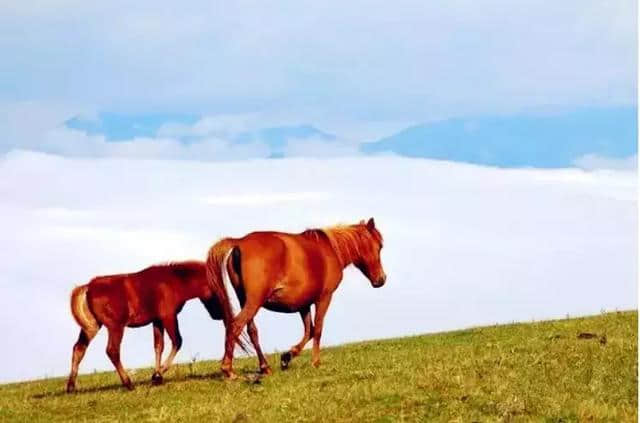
left=353, top=217, right=387, bottom=288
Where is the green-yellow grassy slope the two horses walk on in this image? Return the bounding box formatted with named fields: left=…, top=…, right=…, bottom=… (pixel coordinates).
left=0, top=311, right=638, bottom=422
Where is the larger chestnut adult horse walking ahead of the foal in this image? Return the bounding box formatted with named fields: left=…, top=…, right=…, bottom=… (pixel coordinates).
left=207, top=218, right=386, bottom=378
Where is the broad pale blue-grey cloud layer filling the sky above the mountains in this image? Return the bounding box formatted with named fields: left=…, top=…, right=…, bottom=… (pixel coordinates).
left=0, top=0, right=637, bottom=122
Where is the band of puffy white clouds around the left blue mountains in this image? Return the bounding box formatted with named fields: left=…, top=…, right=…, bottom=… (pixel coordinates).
left=0, top=103, right=359, bottom=160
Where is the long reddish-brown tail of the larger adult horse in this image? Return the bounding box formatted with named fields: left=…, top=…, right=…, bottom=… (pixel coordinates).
left=207, top=238, right=249, bottom=353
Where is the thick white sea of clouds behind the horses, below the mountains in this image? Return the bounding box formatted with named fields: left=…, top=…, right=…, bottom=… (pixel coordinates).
left=0, top=152, right=638, bottom=382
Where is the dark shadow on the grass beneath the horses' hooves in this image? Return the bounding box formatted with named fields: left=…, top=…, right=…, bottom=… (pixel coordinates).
left=30, top=370, right=262, bottom=399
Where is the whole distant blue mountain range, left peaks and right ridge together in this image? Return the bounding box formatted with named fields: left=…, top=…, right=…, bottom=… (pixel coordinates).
left=65, top=106, right=638, bottom=168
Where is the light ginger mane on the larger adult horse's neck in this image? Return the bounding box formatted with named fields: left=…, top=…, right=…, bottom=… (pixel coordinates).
left=302, top=224, right=382, bottom=265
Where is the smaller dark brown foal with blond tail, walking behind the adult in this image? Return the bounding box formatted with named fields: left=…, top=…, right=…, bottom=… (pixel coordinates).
left=67, top=261, right=243, bottom=392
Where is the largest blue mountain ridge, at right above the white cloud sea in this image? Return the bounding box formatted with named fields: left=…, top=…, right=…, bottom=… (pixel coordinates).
left=361, top=107, right=638, bottom=168
